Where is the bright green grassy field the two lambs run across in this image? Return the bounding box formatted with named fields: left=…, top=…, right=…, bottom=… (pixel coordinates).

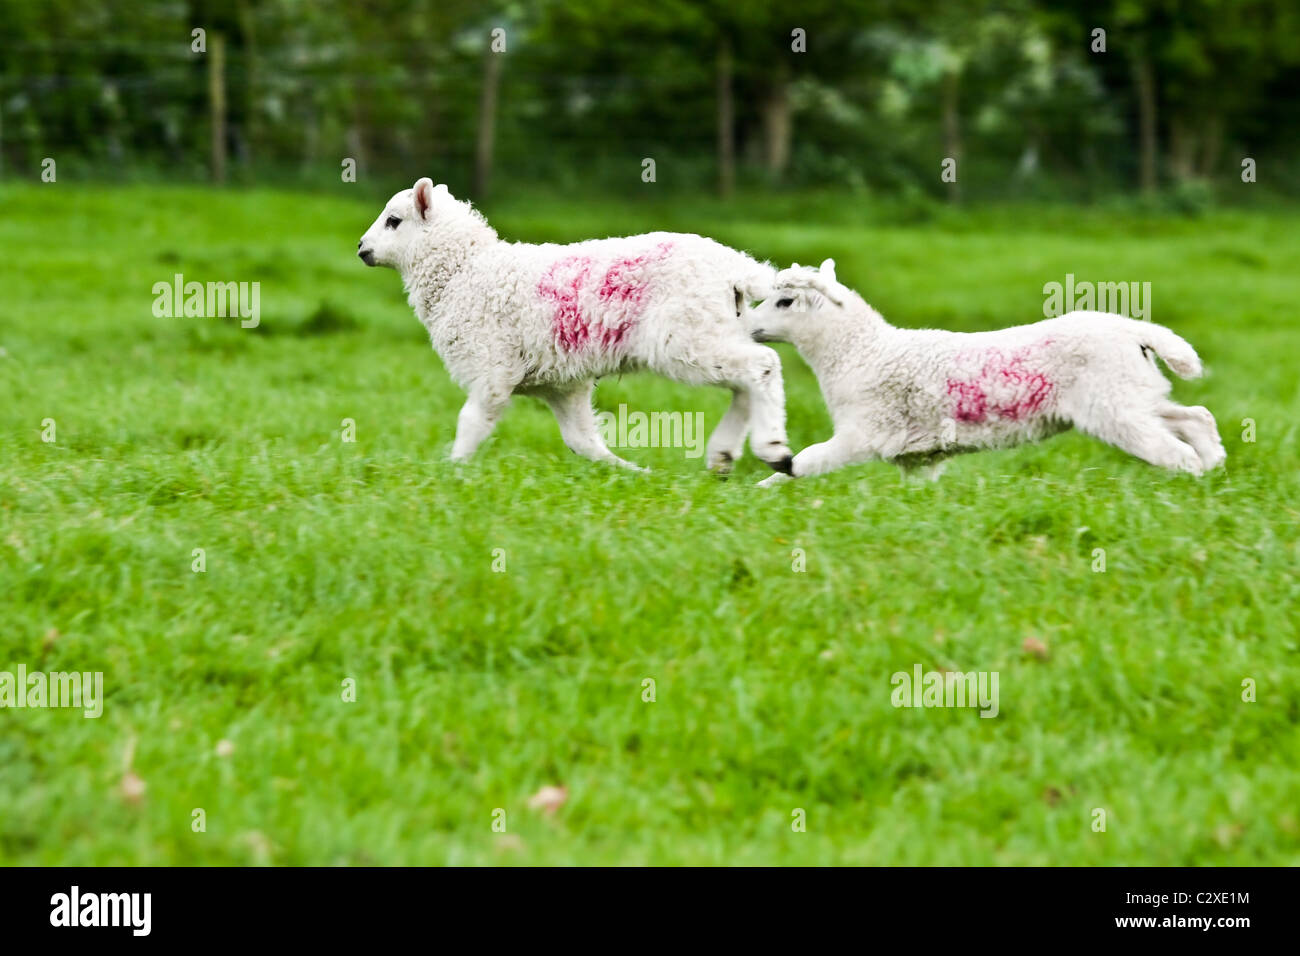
left=0, top=183, right=1300, bottom=865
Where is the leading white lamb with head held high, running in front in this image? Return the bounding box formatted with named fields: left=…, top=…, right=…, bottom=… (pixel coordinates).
left=358, top=178, right=790, bottom=472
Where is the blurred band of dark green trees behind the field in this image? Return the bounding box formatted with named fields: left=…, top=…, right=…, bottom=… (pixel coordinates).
left=0, top=0, right=1300, bottom=198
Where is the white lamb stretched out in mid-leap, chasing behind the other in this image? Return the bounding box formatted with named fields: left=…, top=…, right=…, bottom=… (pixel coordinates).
left=748, top=259, right=1226, bottom=485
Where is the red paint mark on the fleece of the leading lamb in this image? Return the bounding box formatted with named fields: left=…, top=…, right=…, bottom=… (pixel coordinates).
left=537, top=242, right=672, bottom=351
